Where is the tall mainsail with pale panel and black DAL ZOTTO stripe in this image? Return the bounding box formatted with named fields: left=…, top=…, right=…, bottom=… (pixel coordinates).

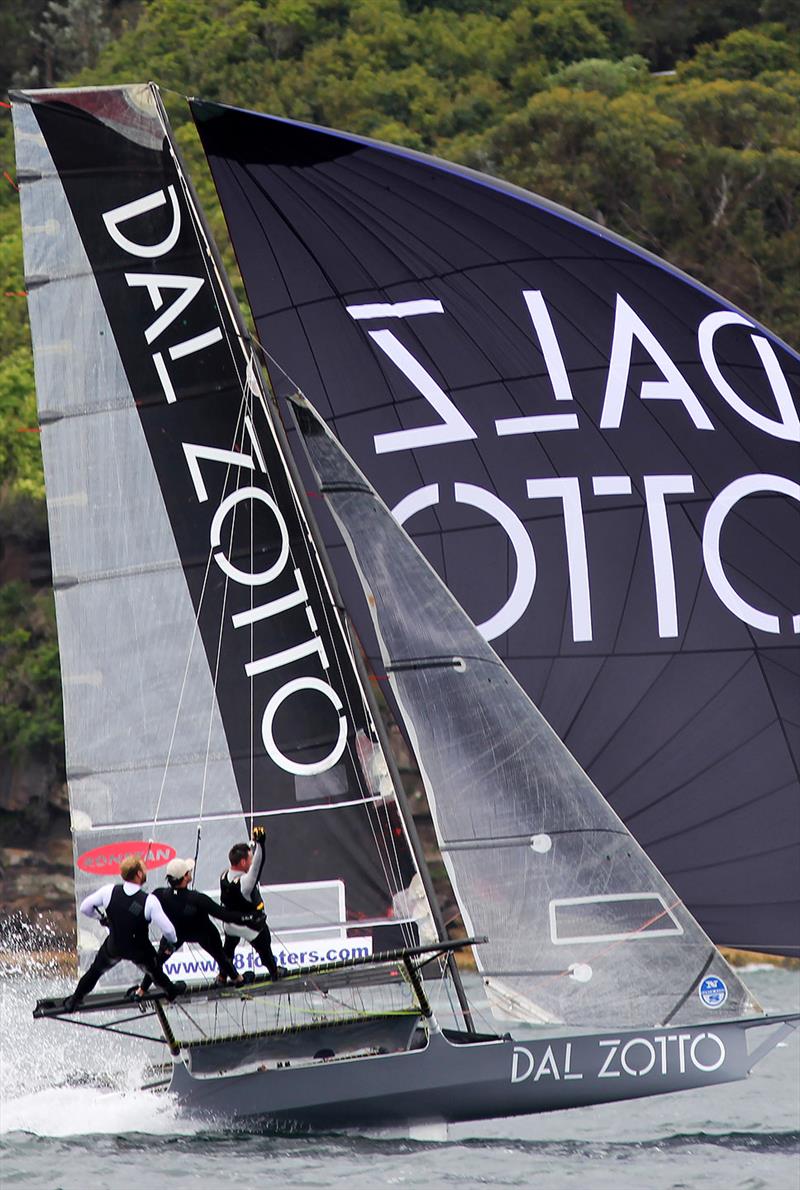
left=14, top=86, right=427, bottom=971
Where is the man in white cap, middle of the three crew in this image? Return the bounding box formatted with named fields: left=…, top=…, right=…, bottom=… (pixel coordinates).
left=138, top=858, right=261, bottom=995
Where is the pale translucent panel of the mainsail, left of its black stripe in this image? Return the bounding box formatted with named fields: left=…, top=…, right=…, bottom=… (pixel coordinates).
left=13, top=87, right=246, bottom=966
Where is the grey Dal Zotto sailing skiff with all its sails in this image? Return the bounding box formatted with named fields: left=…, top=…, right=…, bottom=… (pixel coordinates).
left=13, top=84, right=800, bottom=1127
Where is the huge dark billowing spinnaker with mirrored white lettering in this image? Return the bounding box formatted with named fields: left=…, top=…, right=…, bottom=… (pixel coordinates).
left=193, top=101, right=800, bottom=953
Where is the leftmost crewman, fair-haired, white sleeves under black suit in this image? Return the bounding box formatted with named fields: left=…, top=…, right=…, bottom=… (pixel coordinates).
left=64, top=856, right=186, bottom=1012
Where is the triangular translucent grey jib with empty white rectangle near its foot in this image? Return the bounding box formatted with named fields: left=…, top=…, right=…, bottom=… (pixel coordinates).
left=293, top=396, right=757, bottom=1028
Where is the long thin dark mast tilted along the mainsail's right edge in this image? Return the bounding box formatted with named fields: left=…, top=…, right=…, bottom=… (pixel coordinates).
left=150, top=83, right=475, bottom=1033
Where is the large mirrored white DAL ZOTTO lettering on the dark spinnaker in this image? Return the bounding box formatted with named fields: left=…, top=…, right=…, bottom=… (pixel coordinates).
left=348, top=289, right=800, bottom=641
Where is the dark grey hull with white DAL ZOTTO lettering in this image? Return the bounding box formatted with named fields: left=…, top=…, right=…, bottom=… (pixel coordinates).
left=166, top=1014, right=800, bottom=1128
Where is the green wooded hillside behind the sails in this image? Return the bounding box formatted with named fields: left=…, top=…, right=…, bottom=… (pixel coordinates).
left=0, top=0, right=800, bottom=771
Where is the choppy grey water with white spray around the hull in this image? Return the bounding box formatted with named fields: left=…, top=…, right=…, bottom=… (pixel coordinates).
left=0, top=969, right=800, bottom=1190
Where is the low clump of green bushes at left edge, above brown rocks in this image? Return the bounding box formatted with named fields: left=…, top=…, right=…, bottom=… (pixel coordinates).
left=0, top=582, right=63, bottom=756
